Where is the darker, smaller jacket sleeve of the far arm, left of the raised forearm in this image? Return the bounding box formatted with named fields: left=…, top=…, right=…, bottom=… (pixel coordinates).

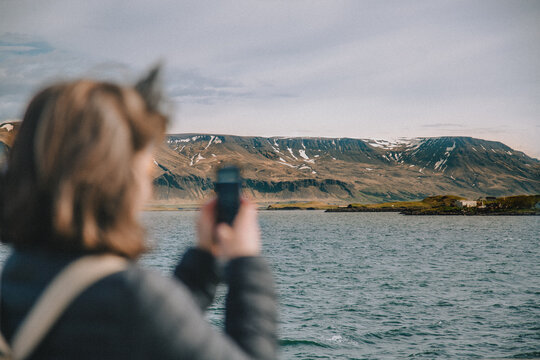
left=174, top=248, right=220, bottom=311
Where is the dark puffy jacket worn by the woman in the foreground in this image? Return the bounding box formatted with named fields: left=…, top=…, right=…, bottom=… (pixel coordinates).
left=0, top=249, right=277, bottom=360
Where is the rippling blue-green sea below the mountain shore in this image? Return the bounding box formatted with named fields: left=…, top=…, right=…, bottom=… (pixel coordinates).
left=0, top=210, right=540, bottom=359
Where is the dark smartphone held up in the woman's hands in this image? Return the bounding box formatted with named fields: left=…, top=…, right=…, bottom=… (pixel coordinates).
left=215, top=165, right=242, bottom=225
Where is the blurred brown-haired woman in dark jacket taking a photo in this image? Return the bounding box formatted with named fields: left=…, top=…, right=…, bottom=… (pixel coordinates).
left=0, top=72, right=277, bottom=360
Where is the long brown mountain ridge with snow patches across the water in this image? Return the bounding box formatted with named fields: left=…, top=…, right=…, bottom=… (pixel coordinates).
left=0, top=122, right=540, bottom=203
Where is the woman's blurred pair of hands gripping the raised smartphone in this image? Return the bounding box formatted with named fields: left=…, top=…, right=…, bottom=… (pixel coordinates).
left=197, top=199, right=261, bottom=260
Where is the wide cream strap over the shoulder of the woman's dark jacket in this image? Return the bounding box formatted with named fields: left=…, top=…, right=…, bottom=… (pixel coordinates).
left=0, top=255, right=128, bottom=360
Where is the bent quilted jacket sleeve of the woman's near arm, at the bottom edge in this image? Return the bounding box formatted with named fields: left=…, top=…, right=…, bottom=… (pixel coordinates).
left=128, top=257, right=277, bottom=360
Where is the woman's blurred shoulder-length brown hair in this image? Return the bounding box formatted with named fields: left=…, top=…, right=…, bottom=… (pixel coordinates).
left=0, top=80, right=167, bottom=258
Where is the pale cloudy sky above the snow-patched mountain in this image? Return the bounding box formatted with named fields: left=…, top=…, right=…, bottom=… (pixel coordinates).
left=0, top=0, right=540, bottom=158
